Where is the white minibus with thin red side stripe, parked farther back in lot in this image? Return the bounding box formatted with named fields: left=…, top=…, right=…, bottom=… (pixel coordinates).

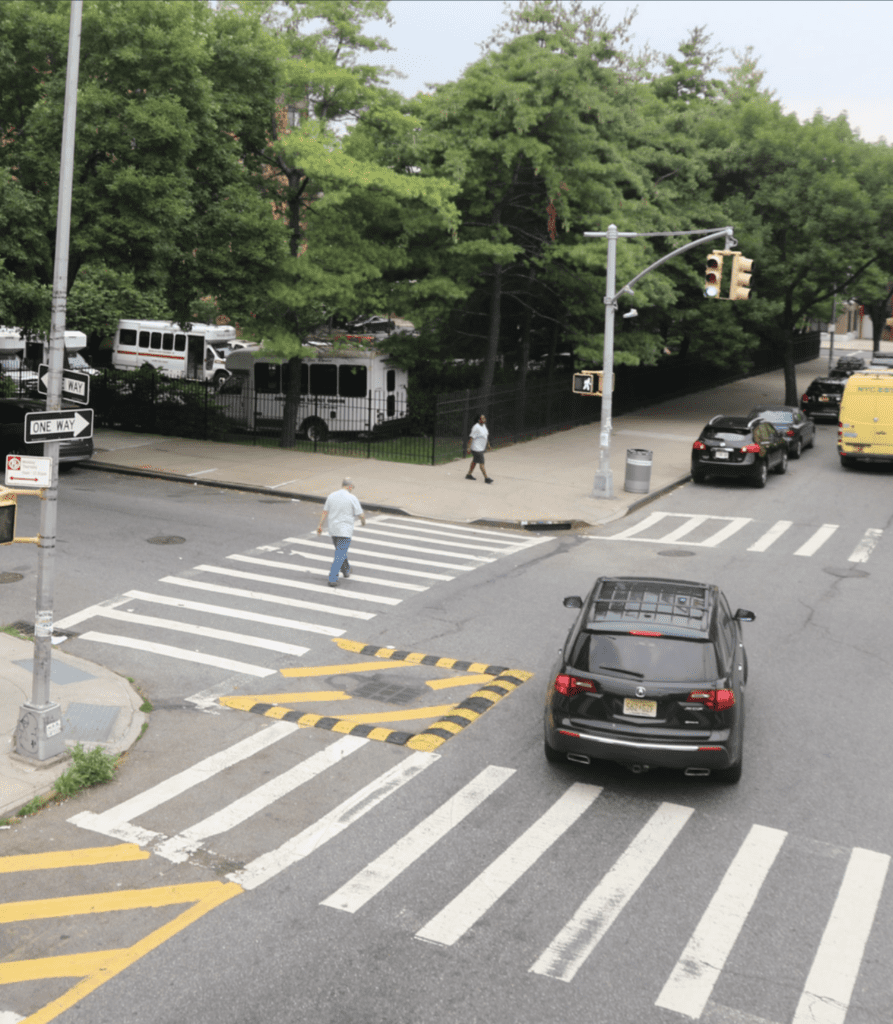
left=112, top=319, right=236, bottom=385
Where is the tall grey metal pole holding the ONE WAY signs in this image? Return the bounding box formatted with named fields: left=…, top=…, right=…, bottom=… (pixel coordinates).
left=15, top=0, right=84, bottom=761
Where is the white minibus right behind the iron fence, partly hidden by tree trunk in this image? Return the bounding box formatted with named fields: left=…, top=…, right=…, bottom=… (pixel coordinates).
left=217, top=346, right=409, bottom=441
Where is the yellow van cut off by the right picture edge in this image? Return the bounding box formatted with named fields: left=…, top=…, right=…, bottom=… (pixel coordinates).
left=838, top=371, right=893, bottom=467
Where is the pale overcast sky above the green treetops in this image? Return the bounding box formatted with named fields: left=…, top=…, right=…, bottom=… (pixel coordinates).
left=367, top=0, right=893, bottom=141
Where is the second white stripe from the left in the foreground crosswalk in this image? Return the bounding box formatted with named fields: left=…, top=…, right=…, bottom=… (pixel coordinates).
left=155, top=736, right=369, bottom=864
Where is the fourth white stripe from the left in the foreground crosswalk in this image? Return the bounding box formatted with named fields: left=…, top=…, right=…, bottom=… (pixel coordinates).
left=321, top=765, right=515, bottom=913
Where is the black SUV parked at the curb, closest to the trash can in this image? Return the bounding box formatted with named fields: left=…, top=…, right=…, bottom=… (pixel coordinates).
left=691, top=416, right=788, bottom=487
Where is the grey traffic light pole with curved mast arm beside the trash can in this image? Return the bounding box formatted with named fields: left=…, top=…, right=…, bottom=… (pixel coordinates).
left=583, top=224, right=735, bottom=498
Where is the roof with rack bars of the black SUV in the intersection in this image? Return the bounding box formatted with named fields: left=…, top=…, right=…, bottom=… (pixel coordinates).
left=588, top=577, right=714, bottom=636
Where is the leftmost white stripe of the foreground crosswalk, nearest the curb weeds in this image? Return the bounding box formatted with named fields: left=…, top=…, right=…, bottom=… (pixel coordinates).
left=69, top=722, right=298, bottom=842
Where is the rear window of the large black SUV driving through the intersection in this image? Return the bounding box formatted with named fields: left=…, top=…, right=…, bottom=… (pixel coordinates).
left=570, top=631, right=719, bottom=683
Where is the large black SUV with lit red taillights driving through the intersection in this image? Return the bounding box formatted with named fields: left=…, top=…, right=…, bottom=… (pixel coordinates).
left=545, top=577, right=756, bottom=782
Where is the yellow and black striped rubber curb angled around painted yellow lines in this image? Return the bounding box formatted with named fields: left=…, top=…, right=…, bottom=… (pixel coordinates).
left=220, top=639, right=533, bottom=751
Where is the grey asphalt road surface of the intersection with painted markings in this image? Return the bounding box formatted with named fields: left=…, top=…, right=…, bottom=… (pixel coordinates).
left=0, top=427, right=893, bottom=1024
